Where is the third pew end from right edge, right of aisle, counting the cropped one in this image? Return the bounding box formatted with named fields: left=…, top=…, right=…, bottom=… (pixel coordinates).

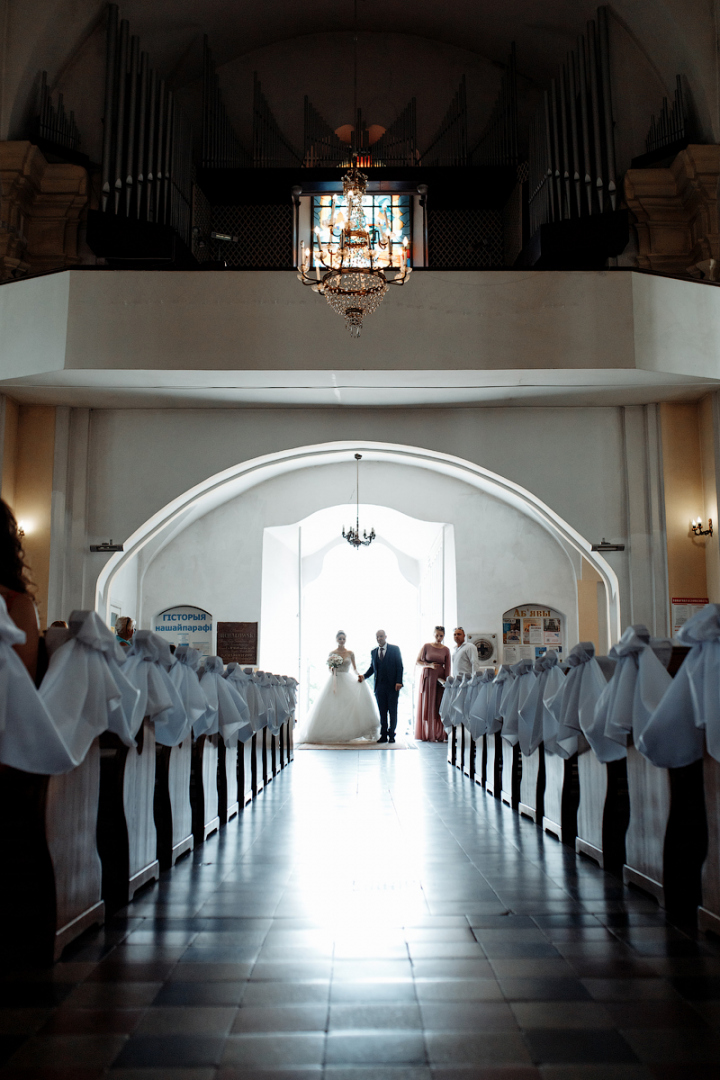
left=575, top=751, right=630, bottom=874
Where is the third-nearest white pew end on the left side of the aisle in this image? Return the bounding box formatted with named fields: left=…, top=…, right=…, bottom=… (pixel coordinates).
left=154, top=735, right=194, bottom=869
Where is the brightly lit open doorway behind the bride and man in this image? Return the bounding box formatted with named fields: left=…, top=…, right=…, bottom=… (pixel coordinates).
left=260, top=504, right=457, bottom=725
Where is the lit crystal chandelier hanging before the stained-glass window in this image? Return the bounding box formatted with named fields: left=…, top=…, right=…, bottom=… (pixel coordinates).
left=298, top=154, right=412, bottom=338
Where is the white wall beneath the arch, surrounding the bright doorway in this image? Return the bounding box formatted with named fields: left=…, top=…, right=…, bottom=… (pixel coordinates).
left=140, top=462, right=578, bottom=663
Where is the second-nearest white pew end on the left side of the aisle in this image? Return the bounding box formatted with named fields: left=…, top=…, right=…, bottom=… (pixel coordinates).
left=97, top=716, right=160, bottom=910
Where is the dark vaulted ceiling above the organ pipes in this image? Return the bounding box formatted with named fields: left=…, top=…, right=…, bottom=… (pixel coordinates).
left=0, top=0, right=718, bottom=125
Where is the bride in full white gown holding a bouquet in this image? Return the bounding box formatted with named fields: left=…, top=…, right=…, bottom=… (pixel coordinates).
left=296, top=631, right=380, bottom=743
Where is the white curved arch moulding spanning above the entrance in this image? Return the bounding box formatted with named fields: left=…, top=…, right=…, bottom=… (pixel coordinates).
left=95, top=442, right=621, bottom=642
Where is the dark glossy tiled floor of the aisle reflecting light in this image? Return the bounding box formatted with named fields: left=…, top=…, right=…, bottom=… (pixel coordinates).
left=0, top=746, right=720, bottom=1080
